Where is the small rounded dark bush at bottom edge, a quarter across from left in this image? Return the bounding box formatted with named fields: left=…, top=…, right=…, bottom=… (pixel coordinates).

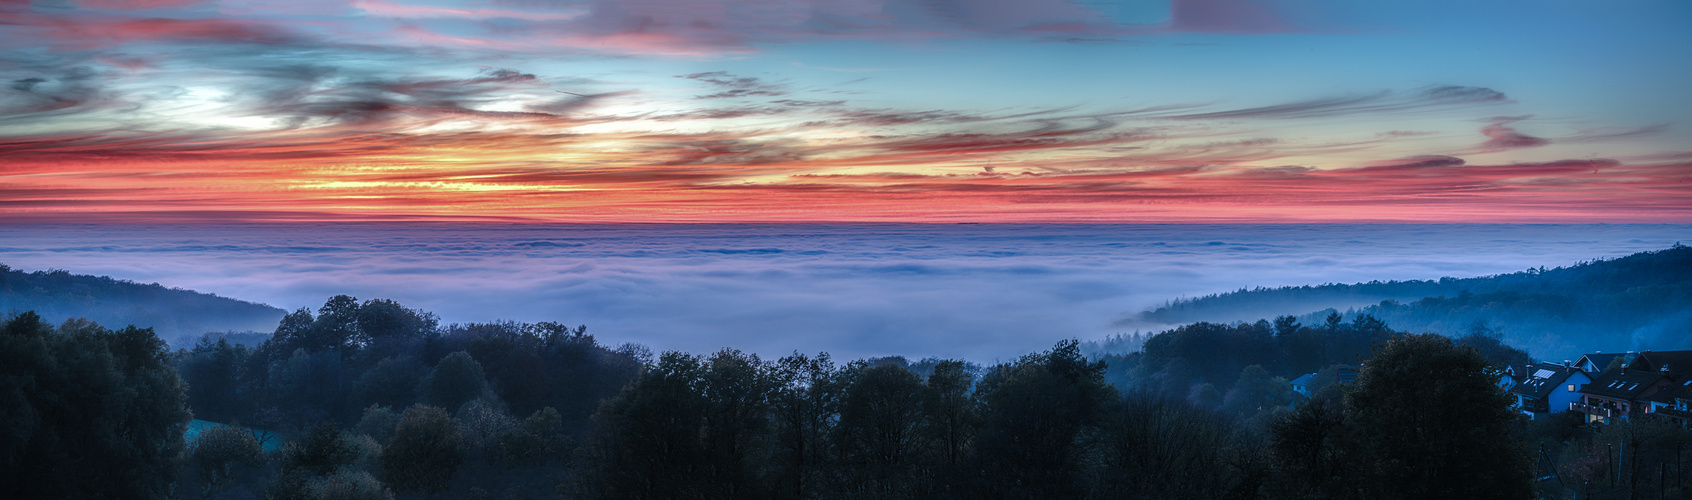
left=381, top=405, right=465, bottom=495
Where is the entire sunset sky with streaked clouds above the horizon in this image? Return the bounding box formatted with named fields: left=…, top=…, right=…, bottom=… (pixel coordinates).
left=0, top=0, right=1692, bottom=223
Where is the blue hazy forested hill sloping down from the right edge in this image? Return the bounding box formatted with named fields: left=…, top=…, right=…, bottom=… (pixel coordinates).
left=1137, top=245, right=1692, bottom=360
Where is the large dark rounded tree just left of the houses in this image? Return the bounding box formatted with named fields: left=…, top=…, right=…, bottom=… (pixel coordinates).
left=1345, top=334, right=1531, bottom=498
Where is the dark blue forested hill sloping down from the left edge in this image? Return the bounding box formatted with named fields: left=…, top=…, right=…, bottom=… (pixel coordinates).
left=0, top=264, right=286, bottom=343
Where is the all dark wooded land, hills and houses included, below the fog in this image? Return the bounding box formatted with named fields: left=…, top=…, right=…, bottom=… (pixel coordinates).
left=0, top=245, right=1692, bottom=498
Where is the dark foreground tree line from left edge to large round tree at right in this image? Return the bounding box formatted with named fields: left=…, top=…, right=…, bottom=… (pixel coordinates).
left=0, top=296, right=1531, bottom=498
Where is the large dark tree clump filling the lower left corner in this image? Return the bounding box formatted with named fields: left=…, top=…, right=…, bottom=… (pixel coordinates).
left=0, top=313, right=190, bottom=498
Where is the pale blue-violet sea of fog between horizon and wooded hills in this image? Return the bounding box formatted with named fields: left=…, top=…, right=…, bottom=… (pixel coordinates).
left=0, top=223, right=1692, bottom=361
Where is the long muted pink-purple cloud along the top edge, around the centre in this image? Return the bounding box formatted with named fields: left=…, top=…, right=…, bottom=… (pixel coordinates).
left=375, top=0, right=1134, bottom=56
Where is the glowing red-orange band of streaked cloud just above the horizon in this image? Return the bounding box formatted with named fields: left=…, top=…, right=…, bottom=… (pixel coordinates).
left=0, top=139, right=1692, bottom=223
